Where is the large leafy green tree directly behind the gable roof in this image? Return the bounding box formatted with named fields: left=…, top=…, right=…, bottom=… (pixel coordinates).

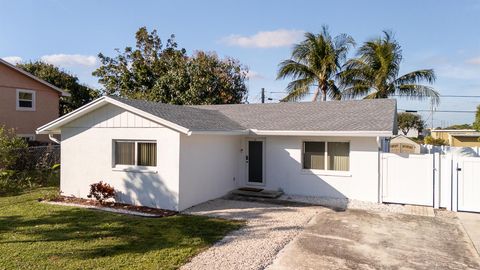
left=93, top=27, right=247, bottom=104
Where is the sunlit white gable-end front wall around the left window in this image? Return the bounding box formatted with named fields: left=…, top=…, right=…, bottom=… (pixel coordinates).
left=60, top=105, right=180, bottom=210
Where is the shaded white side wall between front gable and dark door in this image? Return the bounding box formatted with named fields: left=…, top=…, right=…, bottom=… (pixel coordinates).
left=180, top=134, right=243, bottom=210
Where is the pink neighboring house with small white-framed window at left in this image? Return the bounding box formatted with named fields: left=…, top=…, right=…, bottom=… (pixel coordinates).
left=0, top=59, right=70, bottom=142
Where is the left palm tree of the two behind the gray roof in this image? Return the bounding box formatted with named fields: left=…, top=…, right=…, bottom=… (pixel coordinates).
left=277, top=26, right=355, bottom=101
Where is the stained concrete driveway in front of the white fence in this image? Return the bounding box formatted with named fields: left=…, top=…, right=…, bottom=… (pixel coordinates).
left=267, top=209, right=480, bottom=270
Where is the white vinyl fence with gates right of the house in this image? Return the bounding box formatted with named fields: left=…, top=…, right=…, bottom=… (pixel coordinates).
left=381, top=153, right=480, bottom=212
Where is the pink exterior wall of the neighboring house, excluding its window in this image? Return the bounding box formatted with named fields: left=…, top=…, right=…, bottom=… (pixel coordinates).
left=0, top=64, right=60, bottom=141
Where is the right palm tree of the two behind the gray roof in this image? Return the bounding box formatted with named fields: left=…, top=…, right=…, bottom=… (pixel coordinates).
left=340, top=31, right=439, bottom=104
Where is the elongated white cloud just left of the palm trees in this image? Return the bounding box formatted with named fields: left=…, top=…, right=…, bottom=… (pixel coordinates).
left=222, top=29, right=304, bottom=48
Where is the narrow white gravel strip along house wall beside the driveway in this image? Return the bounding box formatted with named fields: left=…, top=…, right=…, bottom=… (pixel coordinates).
left=279, top=195, right=408, bottom=213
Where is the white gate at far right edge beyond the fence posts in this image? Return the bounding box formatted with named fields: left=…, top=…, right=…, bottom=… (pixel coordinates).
left=457, top=157, right=480, bottom=212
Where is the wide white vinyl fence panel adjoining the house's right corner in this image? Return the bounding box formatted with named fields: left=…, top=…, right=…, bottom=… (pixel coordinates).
left=381, top=153, right=434, bottom=206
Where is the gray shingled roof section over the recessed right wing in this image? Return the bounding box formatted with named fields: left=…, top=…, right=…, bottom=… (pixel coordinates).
left=112, top=97, right=396, bottom=132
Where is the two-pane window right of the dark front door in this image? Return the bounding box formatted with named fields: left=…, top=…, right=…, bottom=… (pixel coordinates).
left=303, top=142, right=350, bottom=171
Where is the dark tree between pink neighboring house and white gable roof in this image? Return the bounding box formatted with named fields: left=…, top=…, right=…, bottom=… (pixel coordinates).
left=17, top=61, right=100, bottom=115
